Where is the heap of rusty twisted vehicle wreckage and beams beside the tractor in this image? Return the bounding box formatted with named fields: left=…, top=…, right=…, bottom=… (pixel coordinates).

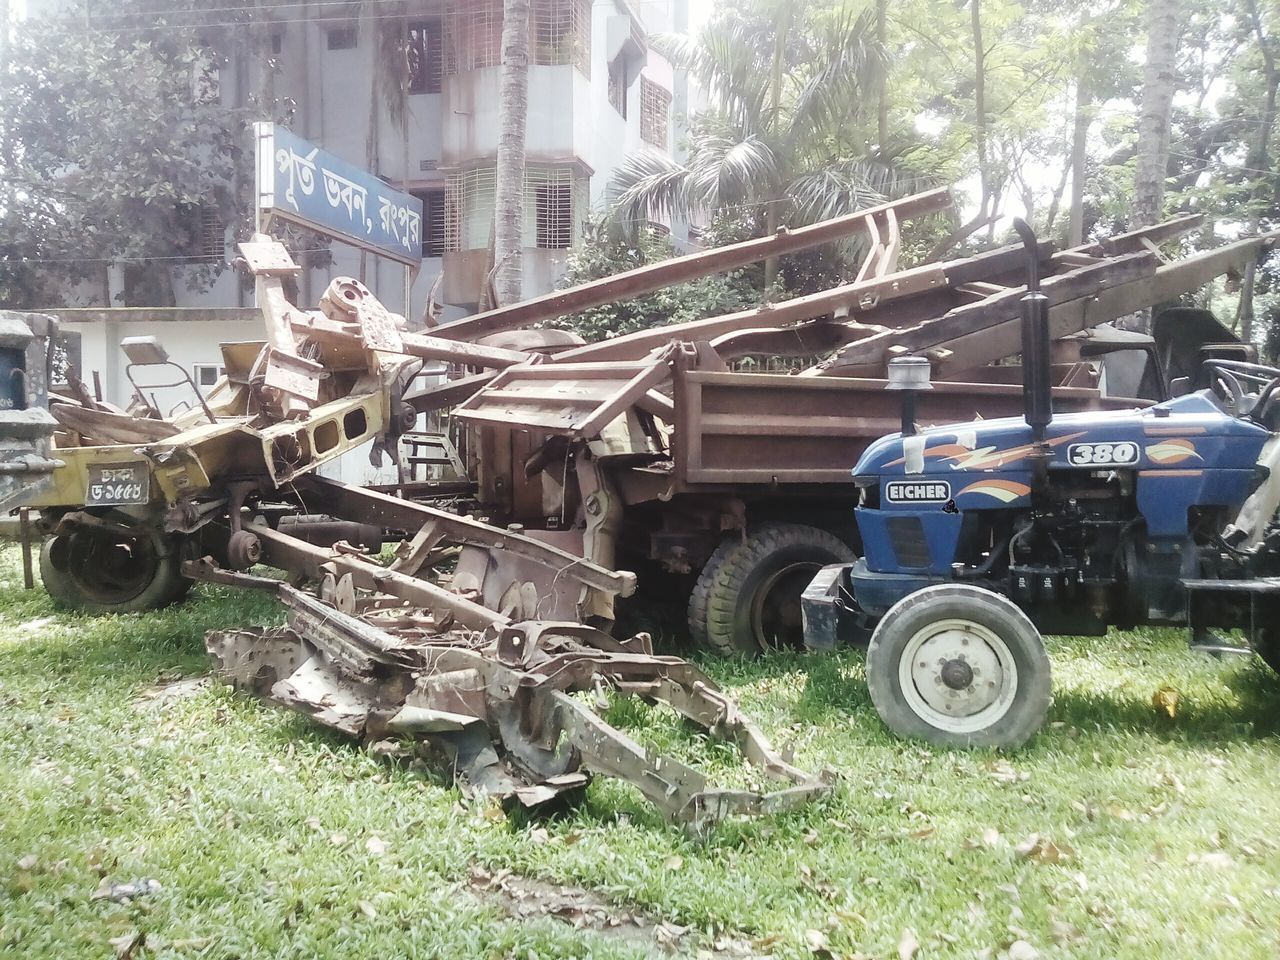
left=15, top=191, right=1271, bottom=823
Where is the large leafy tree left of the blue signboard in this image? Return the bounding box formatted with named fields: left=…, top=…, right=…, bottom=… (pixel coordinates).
left=0, top=0, right=293, bottom=307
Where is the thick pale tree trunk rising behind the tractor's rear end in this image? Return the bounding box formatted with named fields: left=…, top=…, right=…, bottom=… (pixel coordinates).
left=1129, top=0, right=1183, bottom=227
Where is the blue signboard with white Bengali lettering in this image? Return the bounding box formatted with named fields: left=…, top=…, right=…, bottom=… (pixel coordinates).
left=255, top=123, right=422, bottom=266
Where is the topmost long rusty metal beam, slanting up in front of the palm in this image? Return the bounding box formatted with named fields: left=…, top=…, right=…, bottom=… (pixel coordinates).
left=434, top=189, right=951, bottom=340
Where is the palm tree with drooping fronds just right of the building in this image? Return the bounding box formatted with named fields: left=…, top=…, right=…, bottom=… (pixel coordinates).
left=614, top=0, right=919, bottom=284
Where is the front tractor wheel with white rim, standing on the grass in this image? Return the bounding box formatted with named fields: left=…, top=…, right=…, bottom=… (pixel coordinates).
left=867, top=584, right=1051, bottom=748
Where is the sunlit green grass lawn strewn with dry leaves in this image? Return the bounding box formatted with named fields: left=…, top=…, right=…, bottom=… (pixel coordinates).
left=0, top=548, right=1280, bottom=960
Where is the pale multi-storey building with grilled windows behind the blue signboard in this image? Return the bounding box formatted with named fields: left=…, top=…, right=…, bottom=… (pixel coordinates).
left=28, top=0, right=689, bottom=417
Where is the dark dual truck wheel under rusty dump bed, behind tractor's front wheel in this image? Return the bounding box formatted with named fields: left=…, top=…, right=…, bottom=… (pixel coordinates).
left=689, top=524, right=855, bottom=655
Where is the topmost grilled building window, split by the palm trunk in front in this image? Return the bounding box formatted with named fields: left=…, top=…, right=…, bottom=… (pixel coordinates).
left=444, top=0, right=591, bottom=77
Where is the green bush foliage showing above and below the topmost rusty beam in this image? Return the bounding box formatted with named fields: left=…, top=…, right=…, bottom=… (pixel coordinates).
left=548, top=220, right=760, bottom=342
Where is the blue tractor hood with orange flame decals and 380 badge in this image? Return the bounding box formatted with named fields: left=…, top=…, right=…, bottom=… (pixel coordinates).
left=854, top=390, right=1268, bottom=483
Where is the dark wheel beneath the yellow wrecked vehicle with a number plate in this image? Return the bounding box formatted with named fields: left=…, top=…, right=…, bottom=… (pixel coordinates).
left=40, top=530, right=191, bottom=613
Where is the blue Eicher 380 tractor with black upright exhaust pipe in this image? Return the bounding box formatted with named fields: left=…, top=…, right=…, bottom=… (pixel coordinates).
left=803, top=223, right=1280, bottom=746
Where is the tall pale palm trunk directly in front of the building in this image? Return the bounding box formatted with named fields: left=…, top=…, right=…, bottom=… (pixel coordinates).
left=493, top=0, right=529, bottom=306
